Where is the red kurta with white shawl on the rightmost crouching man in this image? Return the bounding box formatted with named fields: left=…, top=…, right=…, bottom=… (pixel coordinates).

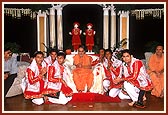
left=123, top=58, right=152, bottom=91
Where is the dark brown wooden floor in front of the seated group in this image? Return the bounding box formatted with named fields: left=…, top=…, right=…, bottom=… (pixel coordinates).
left=2, top=93, right=165, bottom=113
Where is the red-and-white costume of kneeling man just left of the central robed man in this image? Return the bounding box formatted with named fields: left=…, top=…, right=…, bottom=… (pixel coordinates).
left=45, top=56, right=73, bottom=104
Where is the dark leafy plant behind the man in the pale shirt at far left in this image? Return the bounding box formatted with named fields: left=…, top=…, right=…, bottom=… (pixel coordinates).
left=4, top=42, right=21, bottom=53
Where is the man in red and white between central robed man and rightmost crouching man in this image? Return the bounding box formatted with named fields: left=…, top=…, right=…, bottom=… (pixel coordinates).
left=103, top=49, right=123, bottom=97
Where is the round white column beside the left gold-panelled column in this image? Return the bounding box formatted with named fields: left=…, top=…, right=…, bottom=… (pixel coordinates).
left=50, top=7, right=56, bottom=48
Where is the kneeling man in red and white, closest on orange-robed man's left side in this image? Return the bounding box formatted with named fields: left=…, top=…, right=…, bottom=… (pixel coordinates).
left=44, top=51, right=73, bottom=104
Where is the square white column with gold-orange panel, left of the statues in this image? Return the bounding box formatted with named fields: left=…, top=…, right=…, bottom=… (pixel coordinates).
left=37, top=10, right=47, bottom=52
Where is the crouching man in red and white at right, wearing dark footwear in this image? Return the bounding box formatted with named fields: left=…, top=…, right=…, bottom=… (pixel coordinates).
left=116, top=49, right=152, bottom=108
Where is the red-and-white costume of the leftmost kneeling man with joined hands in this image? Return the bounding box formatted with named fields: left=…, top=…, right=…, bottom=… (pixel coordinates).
left=24, top=59, right=47, bottom=104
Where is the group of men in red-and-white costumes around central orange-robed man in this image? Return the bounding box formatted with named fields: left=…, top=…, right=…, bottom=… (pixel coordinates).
left=4, top=46, right=163, bottom=108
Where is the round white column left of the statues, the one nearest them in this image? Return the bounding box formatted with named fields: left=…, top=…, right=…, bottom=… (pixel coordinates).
left=54, top=5, right=63, bottom=50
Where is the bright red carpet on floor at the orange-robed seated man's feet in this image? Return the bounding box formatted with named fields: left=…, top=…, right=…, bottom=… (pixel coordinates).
left=70, top=92, right=121, bottom=103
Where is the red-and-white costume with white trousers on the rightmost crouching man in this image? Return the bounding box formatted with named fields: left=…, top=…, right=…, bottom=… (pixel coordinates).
left=119, top=57, right=152, bottom=101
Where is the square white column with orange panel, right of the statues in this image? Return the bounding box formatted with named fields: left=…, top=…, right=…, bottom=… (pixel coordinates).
left=120, top=11, right=129, bottom=49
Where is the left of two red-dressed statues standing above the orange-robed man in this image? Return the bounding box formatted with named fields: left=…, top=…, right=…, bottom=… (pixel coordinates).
left=69, top=22, right=82, bottom=51
